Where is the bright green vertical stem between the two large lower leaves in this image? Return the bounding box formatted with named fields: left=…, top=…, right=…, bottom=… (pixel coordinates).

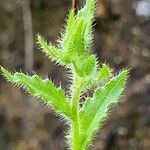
left=71, top=76, right=81, bottom=150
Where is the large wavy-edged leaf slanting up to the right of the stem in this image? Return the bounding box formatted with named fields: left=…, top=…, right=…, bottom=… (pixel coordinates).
left=79, top=70, right=128, bottom=149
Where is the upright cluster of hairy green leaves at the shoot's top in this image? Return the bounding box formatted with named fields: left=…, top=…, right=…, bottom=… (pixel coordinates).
left=58, top=0, right=95, bottom=63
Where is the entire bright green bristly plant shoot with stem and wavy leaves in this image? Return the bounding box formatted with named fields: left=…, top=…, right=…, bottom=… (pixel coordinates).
left=1, top=0, right=128, bottom=150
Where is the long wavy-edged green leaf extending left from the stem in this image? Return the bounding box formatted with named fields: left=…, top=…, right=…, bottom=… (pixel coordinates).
left=1, top=67, right=71, bottom=117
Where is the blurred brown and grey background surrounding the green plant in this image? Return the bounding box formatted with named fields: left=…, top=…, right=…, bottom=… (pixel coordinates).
left=0, top=0, right=150, bottom=150
